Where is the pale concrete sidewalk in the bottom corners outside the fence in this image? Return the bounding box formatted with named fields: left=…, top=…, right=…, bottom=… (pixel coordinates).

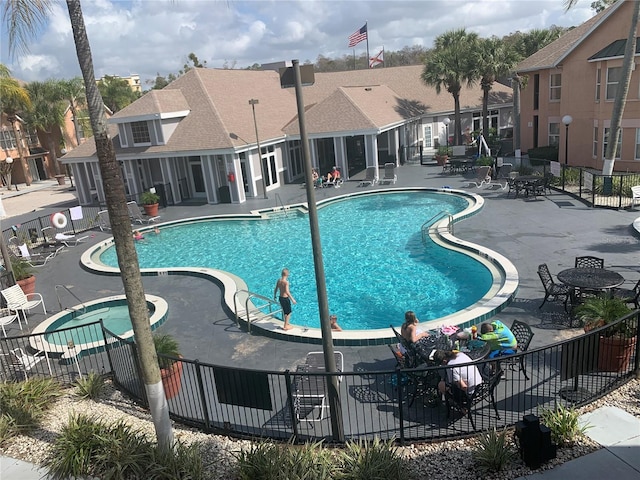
left=0, top=407, right=640, bottom=480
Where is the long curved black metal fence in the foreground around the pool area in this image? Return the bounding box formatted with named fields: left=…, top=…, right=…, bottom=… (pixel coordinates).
left=0, top=311, right=640, bottom=442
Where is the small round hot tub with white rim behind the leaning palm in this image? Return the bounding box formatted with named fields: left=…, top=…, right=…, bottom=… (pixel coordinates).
left=33, top=295, right=168, bottom=353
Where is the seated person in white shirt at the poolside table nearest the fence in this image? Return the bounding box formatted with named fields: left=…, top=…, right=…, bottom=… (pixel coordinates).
left=436, top=350, right=482, bottom=409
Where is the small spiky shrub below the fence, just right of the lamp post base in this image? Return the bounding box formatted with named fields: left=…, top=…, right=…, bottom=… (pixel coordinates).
left=340, top=438, right=406, bottom=480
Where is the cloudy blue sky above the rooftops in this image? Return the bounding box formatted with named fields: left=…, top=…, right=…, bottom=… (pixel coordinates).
left=0, top=0, right=594, bottom=89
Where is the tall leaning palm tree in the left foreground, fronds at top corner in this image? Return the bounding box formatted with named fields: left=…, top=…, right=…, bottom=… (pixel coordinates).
left=3, top=0, right=173, bottom=451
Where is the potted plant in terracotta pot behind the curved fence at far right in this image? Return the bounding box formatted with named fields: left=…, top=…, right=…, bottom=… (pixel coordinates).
left=575, top=296, right=636, bottom=372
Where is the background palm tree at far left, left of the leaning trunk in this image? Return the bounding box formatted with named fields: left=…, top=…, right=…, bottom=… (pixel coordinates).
left=25, top=80, right=66, bottom=176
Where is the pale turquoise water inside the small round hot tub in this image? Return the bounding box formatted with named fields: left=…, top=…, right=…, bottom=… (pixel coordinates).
left=45, top=303, right=144, bottom=345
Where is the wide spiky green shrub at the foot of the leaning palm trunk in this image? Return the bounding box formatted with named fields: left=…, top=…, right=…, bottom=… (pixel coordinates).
left=45, top=415, right=203, bottom=480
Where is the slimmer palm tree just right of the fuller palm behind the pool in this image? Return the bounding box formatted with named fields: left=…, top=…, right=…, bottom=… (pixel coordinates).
left=476, top=37, right=519, bottom=141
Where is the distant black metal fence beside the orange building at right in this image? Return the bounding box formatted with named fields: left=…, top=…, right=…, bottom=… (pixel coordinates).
left=503, top=157, right=640, bottom=209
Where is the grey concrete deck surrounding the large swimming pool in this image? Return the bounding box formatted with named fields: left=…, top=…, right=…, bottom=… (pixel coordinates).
left=5, top=165, right=640, bottom=370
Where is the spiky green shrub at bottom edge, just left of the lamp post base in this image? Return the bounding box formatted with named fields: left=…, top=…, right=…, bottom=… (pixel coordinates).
left=237, top=441, right=335, bottom=480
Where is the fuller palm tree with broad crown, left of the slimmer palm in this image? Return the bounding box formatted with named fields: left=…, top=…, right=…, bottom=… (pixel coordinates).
left=422, top=28, right=479, bottom=145
